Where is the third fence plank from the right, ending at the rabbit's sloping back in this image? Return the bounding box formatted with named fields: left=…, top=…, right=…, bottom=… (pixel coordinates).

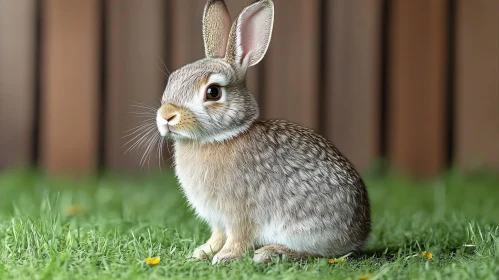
left=321, top=0, right=382, bottom=170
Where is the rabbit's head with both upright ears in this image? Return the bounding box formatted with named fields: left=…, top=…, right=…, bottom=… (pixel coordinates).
left=156, top=0, right=274, bottom=143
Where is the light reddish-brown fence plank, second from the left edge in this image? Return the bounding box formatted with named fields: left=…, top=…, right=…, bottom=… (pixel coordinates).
left=40, top=0, right=100, bottom=173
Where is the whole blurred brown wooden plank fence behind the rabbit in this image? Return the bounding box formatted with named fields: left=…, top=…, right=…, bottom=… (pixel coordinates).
left=0, top=0, right=499, bottom=176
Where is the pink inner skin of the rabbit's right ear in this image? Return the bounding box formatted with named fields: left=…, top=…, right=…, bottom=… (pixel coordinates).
left=239, top=7, right=271, bottom=64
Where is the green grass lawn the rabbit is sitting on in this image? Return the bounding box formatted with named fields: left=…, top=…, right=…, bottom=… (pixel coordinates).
left=0, top=167, right=499, bottom=280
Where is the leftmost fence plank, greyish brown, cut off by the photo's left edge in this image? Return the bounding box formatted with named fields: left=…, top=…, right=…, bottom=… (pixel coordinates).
left=0, top=0, right=36, bottom=169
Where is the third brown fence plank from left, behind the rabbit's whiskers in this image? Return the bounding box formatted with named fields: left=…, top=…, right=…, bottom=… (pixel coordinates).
left=105, top=0, right=167, bottom=171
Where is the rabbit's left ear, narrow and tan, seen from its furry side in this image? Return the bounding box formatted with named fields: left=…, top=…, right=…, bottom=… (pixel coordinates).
left=203, top=0, right=231, bottom=58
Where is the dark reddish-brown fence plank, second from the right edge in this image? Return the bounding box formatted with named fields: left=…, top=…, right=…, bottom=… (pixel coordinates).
left=388, top=0, right=448, bottom=176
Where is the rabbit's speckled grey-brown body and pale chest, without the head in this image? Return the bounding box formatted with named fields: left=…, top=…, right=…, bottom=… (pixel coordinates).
left=175, top=120, right=370, bottom=261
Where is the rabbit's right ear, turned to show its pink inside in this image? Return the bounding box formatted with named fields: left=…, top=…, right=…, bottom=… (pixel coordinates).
left=225, top=0, right=274, bottom=68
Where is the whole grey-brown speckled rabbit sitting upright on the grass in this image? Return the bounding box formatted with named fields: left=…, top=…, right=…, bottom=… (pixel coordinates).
left=156, top=0, right=371, bottom=264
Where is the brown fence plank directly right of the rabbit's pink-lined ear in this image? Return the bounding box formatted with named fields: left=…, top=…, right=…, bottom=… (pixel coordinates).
left=261, top=0, right=320, bottom=129
